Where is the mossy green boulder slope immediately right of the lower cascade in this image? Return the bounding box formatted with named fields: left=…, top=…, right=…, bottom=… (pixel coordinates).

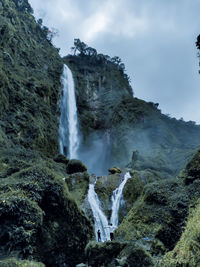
left=115, top=179, right=189, bottom=252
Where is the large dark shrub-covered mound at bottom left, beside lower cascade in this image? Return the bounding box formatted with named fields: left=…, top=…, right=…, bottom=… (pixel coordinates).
left=0, top=149, right=93, bottom=266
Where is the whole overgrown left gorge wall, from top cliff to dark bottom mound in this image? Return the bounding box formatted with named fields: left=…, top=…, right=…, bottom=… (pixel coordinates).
left=0, top=0, right=93, bottom=266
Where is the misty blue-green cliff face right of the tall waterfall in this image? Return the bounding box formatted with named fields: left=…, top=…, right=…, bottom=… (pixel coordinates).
left=64, top=54, right=200, bottom=177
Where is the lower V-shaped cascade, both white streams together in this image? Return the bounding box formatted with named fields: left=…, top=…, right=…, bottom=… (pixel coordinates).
left=88, top=172, right=131, bottom=242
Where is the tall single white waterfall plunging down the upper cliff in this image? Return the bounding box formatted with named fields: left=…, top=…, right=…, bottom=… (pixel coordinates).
left=59, top=65, right=79, bottom=159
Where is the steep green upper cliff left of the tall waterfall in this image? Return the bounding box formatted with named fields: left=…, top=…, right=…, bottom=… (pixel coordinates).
left=0, top=0, right=63, bottom=155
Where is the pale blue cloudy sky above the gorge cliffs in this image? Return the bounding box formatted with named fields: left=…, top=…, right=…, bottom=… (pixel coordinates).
left=29, top=0, right=200, bottom=124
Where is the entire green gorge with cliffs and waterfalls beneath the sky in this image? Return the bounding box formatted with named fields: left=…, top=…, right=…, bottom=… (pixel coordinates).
left=0, top=0, right=200, bottom=267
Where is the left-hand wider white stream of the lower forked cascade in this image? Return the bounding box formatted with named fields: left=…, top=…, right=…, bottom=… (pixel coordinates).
left=88, top=184, right=110, bottom=242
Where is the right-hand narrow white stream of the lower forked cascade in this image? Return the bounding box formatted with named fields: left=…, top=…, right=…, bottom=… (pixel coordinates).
left=110, top=172, right=131, bottom=228
